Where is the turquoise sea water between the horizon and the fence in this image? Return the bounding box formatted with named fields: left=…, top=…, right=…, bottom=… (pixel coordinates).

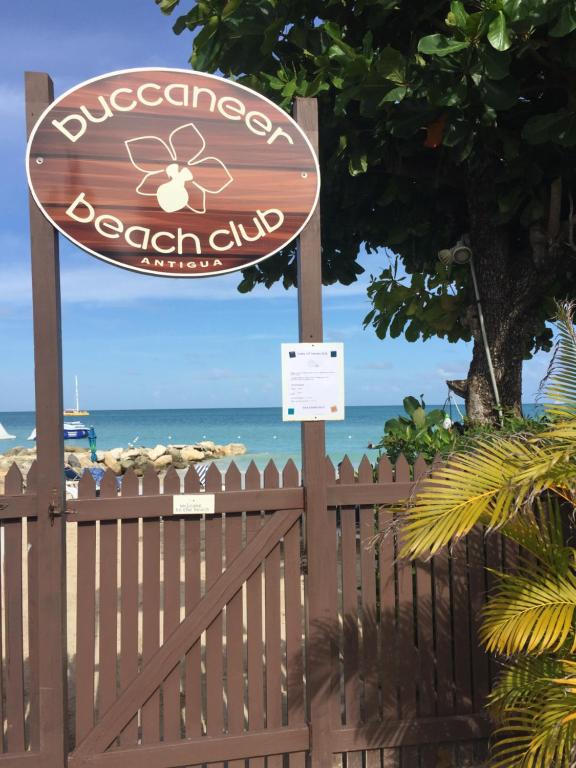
left=0, top=405, right=536, bottom=470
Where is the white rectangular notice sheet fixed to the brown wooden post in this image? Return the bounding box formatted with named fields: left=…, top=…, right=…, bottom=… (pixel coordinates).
left=282, top=343, right=344, bottom=421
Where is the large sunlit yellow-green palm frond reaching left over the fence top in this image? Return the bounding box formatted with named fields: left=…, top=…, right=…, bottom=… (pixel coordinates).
left=401, top=438, right=538, bottom=557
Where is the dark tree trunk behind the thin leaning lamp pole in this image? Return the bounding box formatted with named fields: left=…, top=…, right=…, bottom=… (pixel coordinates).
left=466, top=179, right=538, bottom=423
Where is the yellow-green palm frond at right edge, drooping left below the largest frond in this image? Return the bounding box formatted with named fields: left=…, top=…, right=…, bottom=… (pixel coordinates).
left=480, top=564, right=576, bottom=656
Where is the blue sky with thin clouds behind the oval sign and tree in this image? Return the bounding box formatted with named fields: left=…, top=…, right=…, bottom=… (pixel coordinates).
left=0, top=0, right=547, bottom=411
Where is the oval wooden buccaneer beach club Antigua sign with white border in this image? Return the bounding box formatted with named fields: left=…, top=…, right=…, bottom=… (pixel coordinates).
left=26, top=69, right=320, bottom=277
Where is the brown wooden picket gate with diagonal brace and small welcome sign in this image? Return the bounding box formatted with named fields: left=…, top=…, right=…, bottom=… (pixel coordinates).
left=68, top=464, right=309, bottom=768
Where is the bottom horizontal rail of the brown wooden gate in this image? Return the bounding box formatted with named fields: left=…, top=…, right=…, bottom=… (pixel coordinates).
left=71, top=727, right=309, bottom=768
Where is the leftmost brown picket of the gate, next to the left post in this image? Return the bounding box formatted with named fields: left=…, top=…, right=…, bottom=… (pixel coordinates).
left=75, top=520, right=96, bottom=742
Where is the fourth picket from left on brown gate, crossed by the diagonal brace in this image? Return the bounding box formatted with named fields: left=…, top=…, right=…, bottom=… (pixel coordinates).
left=142, top=469, right=160, bottom=744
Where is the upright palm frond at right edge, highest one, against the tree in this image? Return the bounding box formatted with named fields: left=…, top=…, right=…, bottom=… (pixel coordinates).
left=543, top=302, right=576, bottom=418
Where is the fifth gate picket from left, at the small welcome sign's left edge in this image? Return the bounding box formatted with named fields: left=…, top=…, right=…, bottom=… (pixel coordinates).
left=162, top=467, right=181, bottom=741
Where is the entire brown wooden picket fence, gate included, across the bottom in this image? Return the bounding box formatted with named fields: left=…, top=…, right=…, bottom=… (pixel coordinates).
left=0, top=458, right=504, bottom=768
